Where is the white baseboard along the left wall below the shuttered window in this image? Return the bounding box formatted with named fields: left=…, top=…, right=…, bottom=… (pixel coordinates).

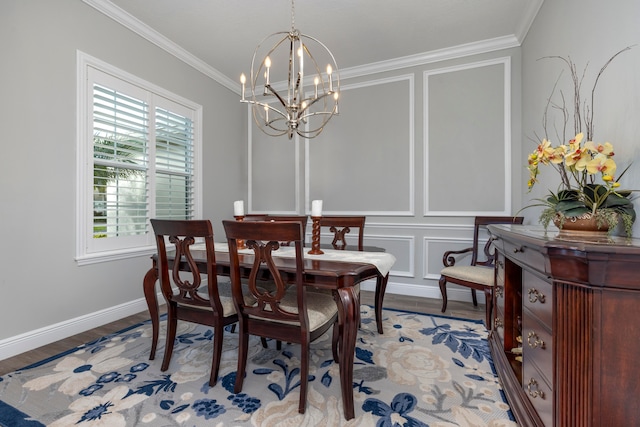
left=0, top=297, right=151, bottom=360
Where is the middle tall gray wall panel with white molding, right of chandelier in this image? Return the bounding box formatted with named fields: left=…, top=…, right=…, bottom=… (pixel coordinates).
left=305, top=74, right=415, bottom=216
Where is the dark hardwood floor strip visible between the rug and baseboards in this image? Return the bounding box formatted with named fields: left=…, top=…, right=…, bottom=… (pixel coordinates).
left=0, top=291, right=484, bottom=375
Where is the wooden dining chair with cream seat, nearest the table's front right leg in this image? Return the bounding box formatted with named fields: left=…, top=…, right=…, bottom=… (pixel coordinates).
left=222, top=221, right=339, bottom=414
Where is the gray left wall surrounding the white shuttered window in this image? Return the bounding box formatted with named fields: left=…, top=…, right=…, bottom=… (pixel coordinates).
left=0, top=0, right=246, bottom=348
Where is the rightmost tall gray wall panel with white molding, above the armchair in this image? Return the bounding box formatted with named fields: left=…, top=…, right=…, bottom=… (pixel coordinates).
left=423, top=58, right=511, bottom=216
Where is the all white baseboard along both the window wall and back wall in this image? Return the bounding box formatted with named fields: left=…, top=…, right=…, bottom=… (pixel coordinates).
left=0, top=280, right=484, bottom=360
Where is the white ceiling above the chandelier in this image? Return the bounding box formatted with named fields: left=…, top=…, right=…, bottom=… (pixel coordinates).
left=102, top=0, right=543, bottom=86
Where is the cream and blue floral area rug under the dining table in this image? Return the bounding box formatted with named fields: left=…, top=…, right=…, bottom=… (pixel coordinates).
left=0, top=305, right=516, bottom=427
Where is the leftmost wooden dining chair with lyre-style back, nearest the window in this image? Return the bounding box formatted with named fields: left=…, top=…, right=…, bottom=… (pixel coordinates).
left=151, top=219, right=238, bottom=387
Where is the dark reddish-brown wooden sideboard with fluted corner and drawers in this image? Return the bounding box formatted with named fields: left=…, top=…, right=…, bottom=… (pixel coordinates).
left=489, top=225, right=640, bottom=427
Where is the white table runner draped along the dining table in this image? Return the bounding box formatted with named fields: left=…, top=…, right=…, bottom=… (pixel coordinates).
left=192, top=242, right=396, bottom=276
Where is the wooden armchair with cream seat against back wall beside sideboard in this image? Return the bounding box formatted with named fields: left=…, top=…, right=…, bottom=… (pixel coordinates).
left=439, top=216, right=524, bottom=329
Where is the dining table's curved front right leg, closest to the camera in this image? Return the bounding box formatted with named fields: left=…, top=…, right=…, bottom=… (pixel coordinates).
left=336, top=287, right=360, bottom=420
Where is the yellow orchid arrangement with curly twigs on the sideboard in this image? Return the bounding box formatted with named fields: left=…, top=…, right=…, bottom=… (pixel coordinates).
left=527, top=47, right=636, bottom=237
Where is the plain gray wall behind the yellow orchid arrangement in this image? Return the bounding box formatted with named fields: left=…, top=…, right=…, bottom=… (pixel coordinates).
left=520, top=0, right=640, bottom=237
